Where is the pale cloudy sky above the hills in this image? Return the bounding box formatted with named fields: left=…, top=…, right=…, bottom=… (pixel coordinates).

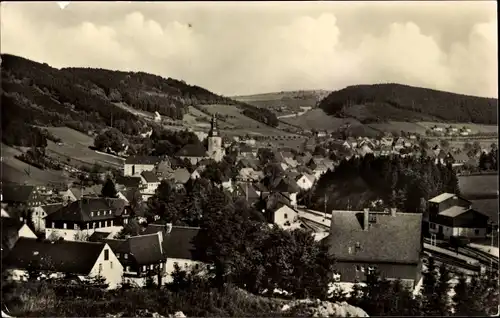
left=0, top=1, right=498, bottom=97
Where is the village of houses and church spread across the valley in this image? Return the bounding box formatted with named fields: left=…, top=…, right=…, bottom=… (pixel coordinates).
left=2, top=115, right=498, bottom=298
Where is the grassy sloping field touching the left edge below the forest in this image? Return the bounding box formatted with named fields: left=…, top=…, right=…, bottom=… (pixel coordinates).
left=1, top=144, right=72, bottom=185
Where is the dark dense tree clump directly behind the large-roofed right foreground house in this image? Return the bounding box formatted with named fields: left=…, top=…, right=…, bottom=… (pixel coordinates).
left=309, top=154, right=460, bottom=212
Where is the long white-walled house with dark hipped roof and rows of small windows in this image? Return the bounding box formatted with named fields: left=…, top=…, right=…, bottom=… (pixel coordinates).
left=45, top=198, right=130, bottom=241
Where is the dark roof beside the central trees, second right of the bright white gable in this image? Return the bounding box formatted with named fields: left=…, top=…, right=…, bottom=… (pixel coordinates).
left=164, top=226, right=204, bottom=261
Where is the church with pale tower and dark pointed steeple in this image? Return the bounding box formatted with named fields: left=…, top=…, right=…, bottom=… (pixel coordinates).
left=176, top=114, right=225, bottom=165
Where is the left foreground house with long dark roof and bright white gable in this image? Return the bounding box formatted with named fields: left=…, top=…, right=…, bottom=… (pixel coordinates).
left=2, top=237, right=123, bottom=289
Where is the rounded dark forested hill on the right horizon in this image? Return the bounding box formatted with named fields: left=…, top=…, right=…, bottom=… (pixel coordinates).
left=319, top=84, right=498, bottom=125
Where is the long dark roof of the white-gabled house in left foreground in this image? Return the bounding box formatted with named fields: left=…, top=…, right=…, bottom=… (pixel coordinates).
left=2, top=237, right=105, bottom=275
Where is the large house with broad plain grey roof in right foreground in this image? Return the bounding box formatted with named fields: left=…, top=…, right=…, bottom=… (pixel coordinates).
left=322, top=209, right=423, bottom=288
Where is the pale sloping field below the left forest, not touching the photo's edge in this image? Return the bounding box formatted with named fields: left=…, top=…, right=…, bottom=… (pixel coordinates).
left=46, top=127, right=123, bottom=168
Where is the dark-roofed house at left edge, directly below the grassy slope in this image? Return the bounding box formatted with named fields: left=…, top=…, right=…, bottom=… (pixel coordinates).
left=1, top=184, right=44, bottom=208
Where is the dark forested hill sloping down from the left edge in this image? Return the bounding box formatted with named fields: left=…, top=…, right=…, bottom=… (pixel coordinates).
left=1, top=54, right=277, bottom=145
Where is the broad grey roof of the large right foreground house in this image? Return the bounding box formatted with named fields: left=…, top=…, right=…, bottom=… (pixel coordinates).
left=325, top=211, right=422, bottom=264
